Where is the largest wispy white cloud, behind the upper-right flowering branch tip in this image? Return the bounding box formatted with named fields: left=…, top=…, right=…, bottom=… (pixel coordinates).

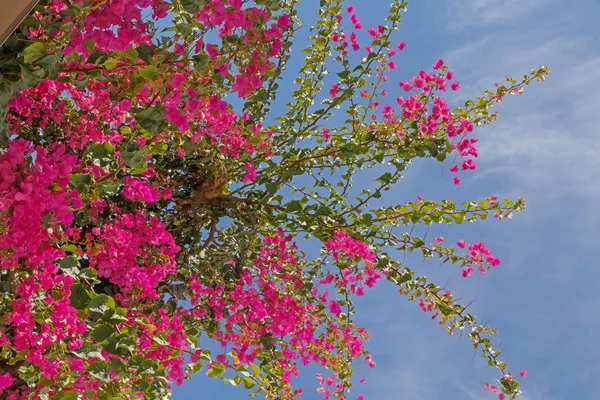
left=438, top=32, right=600, bottom=199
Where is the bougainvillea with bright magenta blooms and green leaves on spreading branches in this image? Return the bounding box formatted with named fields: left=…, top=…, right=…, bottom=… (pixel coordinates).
left=0, top=0, right=548, bottom=400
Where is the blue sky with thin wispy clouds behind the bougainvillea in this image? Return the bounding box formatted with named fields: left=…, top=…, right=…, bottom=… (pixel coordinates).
left=172, top=0, right=600, bottom=400
